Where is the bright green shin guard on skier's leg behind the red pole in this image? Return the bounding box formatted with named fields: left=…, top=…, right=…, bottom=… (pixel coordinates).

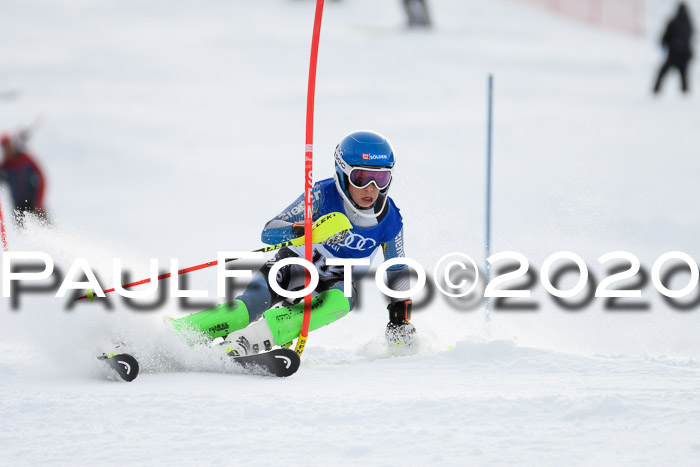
left=265, top=289, right=350, bottom=344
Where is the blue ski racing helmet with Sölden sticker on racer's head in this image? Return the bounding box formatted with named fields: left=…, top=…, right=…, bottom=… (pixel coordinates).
left=335, top=130, right=396, bottom=217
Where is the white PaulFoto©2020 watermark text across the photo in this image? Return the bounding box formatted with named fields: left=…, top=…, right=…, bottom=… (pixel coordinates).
left=1, top=251, right=700, bottom=310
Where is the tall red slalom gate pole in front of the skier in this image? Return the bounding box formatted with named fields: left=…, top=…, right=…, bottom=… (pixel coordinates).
left=295, top=0, right=323, bottom=355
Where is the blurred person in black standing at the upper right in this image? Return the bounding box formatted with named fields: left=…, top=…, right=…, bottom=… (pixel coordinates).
left=654, top=2, right=693, bottom=94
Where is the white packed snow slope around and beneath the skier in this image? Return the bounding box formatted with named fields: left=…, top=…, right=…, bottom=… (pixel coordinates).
left=0, top=0, right=700, bottom=465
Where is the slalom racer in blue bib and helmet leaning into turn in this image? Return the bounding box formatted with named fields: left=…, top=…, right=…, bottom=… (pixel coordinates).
left=173, top=130, right=415, bottom=355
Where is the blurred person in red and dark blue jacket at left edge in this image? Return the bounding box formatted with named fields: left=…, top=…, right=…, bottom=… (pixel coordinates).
left=0, top=131, right=46, bottom=227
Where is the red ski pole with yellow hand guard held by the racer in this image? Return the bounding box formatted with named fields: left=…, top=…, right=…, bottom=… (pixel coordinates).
left=76, top=212, right=352, bottom=301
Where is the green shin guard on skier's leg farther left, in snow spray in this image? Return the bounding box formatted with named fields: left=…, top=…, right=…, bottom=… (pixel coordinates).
left=173, top=300, right=250, bottom=339
